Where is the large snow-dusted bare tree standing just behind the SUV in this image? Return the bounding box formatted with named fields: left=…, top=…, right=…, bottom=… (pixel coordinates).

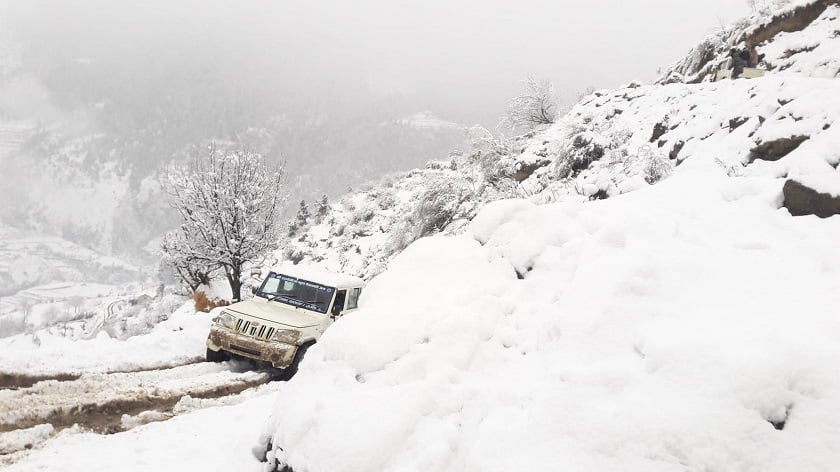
left=162, top=146, right=286, bottom=300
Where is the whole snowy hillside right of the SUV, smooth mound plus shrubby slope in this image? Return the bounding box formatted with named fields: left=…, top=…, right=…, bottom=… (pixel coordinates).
left=265, top=2, right=840, bottom=472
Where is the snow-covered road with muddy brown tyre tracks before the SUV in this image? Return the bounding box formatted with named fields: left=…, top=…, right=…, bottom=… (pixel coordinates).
left=0, top=303, right=285, bottom=471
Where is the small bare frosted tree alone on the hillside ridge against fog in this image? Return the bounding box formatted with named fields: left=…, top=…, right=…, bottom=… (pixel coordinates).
left=501, top=77, right=557, bottom=129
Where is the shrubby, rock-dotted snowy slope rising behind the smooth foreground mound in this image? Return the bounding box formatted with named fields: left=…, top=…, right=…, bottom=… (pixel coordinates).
left=281, top=0, right=840, bottom=278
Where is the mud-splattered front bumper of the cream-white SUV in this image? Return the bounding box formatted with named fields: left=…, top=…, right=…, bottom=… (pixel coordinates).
left=207, top=325, right=297, bottom=369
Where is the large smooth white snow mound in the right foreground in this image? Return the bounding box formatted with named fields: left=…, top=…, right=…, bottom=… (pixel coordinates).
left=271, top=159, right=840, bottom=472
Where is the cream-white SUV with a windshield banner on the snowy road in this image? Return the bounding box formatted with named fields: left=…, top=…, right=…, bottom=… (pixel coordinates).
left=207, top=266, right=365, bottom=376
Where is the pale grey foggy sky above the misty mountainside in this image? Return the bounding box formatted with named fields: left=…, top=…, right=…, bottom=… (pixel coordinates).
left=4, top=0, right=748, bottom=126
